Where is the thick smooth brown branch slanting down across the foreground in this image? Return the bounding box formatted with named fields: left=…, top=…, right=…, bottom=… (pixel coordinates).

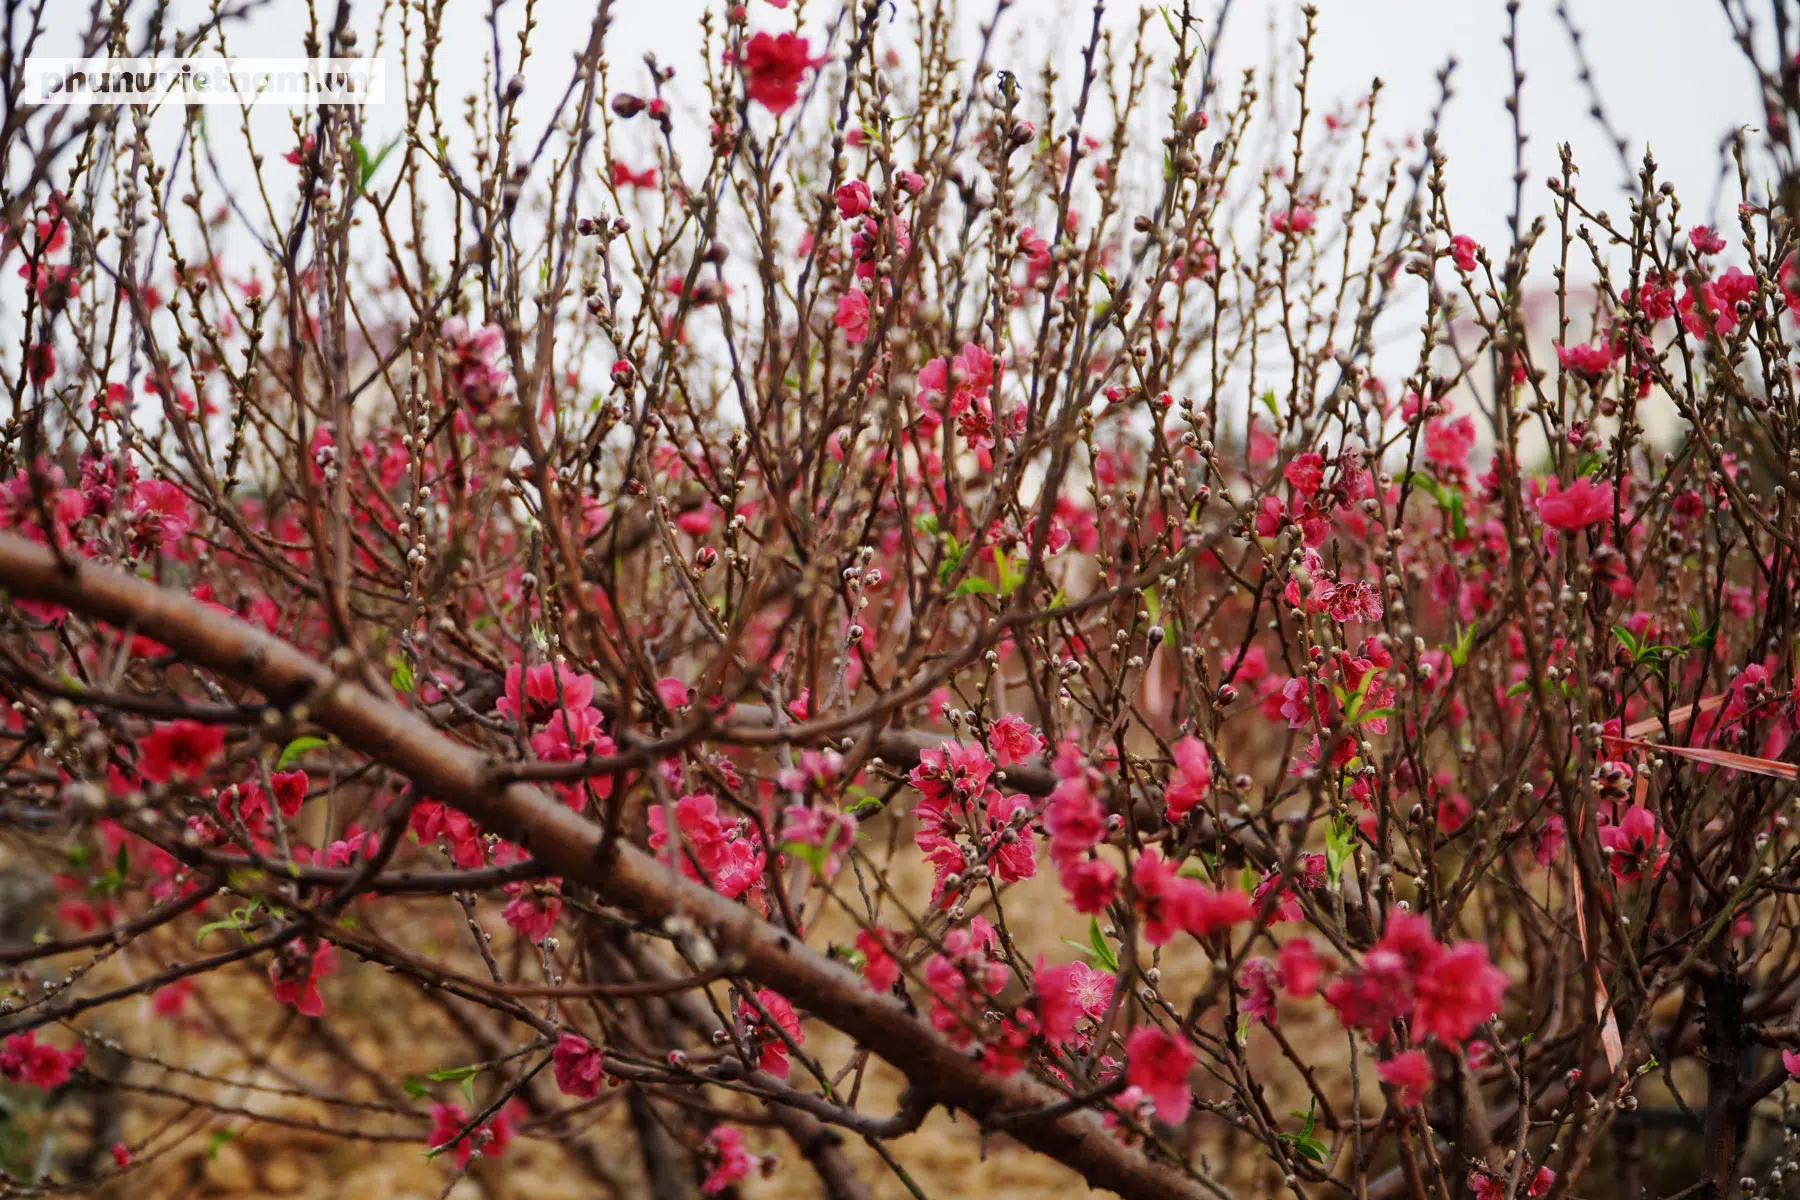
left=0, top=534, right=1228, bottom=1200
